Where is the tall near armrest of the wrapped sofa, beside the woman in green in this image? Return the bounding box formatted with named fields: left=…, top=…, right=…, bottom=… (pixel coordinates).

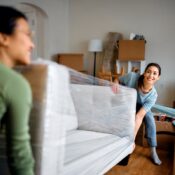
left=17, top=62, right=69, bottom=175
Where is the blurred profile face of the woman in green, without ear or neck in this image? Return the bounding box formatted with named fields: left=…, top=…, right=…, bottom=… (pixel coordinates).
left=6, top=18, right=34, bottom=66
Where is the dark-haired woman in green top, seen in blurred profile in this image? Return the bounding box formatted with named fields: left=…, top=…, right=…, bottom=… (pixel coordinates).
left=0, top=6, right=34, bottom=175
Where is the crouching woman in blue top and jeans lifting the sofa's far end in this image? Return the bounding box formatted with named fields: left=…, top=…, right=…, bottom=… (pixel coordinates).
left=119, top=63, right=161, bottom=165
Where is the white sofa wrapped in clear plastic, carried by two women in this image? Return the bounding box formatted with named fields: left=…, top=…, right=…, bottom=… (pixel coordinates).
left=0, top=60, right=136, bottom=175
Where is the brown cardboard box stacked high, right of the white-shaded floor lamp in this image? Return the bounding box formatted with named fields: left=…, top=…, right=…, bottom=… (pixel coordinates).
left=118, top=40, right=145, bottom=61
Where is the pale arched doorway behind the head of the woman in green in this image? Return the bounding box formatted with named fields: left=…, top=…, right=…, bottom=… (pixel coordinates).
left=16, top=3, right=49, bottom=60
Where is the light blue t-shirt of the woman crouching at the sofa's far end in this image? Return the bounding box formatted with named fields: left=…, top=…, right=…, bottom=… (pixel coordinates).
left=119, top=72, right=158, bottom=112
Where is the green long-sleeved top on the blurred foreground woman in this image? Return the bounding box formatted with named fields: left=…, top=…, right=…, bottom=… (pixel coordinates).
left=0, top=64, right=34, bottom=175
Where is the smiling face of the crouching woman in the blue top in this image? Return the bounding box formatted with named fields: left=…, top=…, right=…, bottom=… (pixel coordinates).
left=144, top=66, right=160, bottom=85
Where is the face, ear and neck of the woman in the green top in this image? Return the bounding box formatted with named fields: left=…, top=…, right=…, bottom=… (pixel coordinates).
left=0, top=15, right=34, bottom=67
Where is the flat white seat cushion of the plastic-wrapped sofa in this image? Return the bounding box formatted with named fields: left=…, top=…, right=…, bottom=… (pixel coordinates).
left=63, top=130, right=133, bottom=175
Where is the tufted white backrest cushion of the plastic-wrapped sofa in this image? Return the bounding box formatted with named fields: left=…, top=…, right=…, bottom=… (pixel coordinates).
left=71, top=84, right=136, bottom=139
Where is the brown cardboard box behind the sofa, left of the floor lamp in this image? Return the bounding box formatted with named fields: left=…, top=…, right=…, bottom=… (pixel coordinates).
left=57, top=53, right=84, bottom=71
